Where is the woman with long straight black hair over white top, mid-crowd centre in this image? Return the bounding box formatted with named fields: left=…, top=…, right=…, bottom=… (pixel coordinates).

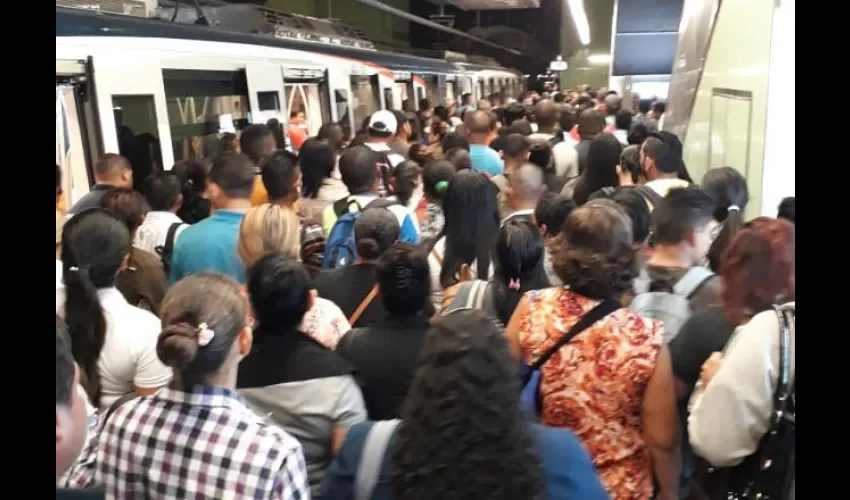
left=426, top=170, right=501, bottom=309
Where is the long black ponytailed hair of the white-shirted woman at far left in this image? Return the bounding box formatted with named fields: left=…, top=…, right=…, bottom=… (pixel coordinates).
left=62, top=208, right=130, bottom=406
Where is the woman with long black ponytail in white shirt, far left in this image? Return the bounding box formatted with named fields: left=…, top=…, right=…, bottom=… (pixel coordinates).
left=56, top=208, right=171, bottom=409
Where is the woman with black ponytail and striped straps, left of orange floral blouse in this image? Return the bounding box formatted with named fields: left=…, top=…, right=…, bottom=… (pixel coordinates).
left=443, top=219, right=549, bottom=327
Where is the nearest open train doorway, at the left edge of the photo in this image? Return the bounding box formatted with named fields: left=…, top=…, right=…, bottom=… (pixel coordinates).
left=56, top=56, right=103, bottom=208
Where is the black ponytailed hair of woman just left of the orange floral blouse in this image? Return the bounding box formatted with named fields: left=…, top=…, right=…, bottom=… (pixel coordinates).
left=493, top=218, right=549, bottom=325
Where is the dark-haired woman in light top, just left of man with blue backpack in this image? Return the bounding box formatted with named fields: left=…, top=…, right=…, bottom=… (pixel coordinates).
left=298, top=137, right=349, bottom=221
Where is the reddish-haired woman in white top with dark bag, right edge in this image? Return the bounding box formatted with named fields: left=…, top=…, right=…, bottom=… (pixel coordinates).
left=688, top=217, right=796, bottom=496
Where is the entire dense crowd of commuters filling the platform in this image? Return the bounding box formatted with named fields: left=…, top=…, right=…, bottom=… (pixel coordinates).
left=56, top=83, right=796, bottom=500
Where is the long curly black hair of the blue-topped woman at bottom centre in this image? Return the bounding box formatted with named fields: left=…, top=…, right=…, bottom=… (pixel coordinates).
left=392, top=310, right=545, bottom=500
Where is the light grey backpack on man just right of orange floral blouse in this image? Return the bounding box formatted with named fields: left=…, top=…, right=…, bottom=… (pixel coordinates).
left=629, top=267, right=714, bottom=342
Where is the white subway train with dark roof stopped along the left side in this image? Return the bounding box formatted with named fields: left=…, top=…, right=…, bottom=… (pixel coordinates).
left=56, top=5, right=524, bottom=204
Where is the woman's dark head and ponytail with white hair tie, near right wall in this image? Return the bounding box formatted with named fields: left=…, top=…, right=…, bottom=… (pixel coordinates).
left=702, top=167, right=750, bottom=273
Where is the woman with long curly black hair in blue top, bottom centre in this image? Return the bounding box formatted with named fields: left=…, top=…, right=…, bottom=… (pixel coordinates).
left=322, top=310, right=608, bottom=500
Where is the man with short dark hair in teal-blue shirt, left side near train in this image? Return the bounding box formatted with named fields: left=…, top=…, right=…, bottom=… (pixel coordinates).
left=169, top=153, right=255, bottom=284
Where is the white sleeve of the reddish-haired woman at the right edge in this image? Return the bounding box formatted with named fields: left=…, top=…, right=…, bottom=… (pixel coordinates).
left=688, top=310, right=779, bottom=467
